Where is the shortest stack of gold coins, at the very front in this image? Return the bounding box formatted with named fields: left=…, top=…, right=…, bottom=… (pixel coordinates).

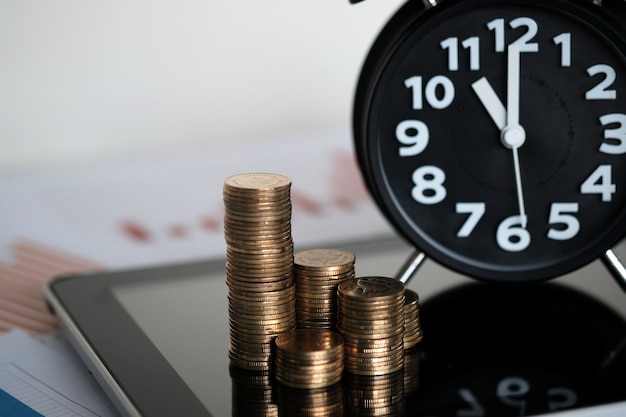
left=276, top=329, right=344, bottom=389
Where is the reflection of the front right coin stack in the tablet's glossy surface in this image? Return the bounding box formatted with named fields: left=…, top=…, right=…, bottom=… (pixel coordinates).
left=344, top=371, right=406, bottom=417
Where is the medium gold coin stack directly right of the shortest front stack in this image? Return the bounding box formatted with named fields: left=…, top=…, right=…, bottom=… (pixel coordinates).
left=337, top=277, right=405, bottom=375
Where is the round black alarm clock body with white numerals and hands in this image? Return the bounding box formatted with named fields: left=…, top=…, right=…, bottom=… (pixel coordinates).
left=354, top=0, right=626, bottom=281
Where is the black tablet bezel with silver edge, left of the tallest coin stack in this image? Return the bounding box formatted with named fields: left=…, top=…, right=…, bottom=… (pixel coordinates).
left=45, top=260, right=216, bottom=417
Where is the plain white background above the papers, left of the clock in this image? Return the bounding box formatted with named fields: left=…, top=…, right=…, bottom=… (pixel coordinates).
left=0, top=0, right=402, bottom=174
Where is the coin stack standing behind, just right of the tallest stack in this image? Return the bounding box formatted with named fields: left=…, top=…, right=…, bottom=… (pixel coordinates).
left=294, top=249, right=355, bottom=329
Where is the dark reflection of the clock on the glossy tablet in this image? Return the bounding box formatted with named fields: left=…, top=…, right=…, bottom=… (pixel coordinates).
left=407, top=283, right=626, bottom=417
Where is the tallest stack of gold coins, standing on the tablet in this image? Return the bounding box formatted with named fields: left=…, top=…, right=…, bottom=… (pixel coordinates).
left=223, top=174, right=296, bottom=370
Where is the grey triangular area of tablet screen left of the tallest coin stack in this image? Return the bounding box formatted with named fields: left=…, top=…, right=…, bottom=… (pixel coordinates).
left=112, top=276, right=231, bottom=416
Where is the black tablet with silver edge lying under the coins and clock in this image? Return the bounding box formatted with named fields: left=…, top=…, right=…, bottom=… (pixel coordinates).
left=46, top=238, right=626, bottom=417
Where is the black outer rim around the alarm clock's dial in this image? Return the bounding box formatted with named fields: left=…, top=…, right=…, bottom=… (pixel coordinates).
left=353, top=0, right=626, bottom=282
